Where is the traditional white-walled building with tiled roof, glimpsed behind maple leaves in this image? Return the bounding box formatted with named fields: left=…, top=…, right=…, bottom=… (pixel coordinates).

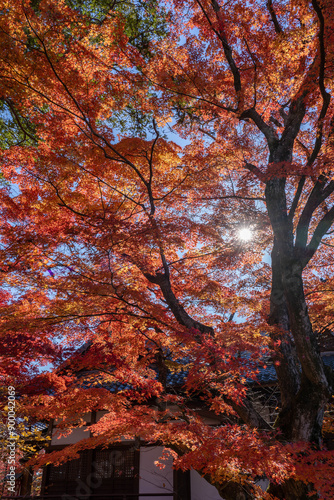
left=3, top=337, right=334, bottom=500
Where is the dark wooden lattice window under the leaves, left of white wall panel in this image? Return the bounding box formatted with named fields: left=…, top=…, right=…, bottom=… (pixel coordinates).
left=44, top=446, right=139, bottom=500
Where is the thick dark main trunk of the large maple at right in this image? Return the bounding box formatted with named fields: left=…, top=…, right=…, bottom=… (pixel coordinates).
left=266, top=175, right=330, bottom=500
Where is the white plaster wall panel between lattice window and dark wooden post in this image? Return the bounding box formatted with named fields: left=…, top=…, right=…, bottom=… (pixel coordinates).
left=139, top=446, right=174, bottom=500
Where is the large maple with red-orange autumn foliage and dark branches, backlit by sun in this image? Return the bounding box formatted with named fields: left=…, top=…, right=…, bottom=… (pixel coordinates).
left=0, top=0, right=334, bottom=500
